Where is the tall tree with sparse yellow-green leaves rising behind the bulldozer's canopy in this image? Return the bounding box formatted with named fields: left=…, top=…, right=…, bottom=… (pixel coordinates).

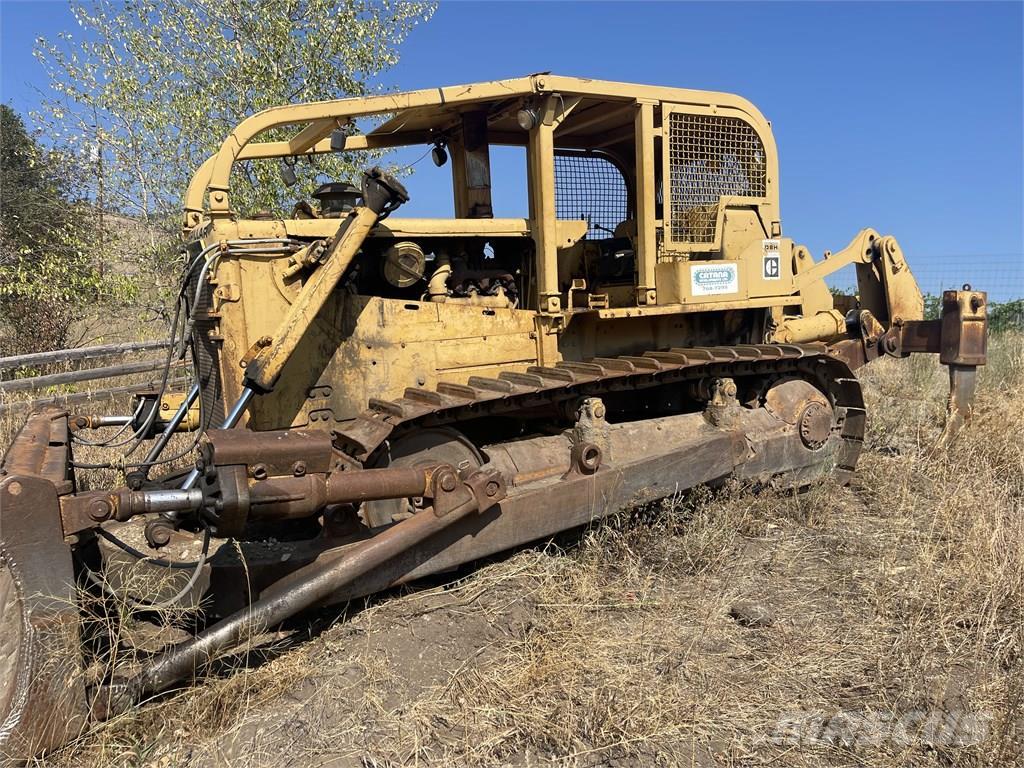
left=36, top=0, right=434, bottom=231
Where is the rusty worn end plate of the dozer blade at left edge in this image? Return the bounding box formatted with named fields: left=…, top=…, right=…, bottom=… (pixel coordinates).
left=0, top=475, right=87, bottom=765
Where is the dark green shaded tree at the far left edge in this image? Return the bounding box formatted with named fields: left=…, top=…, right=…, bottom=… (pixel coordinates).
left=0, top=104, right=112, bottom=353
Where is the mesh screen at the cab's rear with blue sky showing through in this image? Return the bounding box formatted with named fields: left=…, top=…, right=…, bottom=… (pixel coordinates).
left=555, top=154, right=629, bottom=240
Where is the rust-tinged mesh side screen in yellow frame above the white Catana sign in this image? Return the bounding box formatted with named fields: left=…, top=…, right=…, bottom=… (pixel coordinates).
left=669, top=112, right=767, bottom=243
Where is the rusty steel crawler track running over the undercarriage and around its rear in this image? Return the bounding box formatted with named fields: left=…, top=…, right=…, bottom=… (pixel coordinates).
left=336, top=343, right=866, bottom=481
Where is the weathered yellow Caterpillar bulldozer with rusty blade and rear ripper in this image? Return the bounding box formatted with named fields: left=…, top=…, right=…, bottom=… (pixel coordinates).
left=0, top=74, right=986, bottom=758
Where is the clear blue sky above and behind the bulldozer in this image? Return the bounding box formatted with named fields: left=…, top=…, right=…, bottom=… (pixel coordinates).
left=0, top=0, right=1024, bottom=296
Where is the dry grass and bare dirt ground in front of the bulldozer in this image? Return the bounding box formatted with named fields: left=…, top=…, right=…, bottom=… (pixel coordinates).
left=19, top=336, right=1024, bottom=768
